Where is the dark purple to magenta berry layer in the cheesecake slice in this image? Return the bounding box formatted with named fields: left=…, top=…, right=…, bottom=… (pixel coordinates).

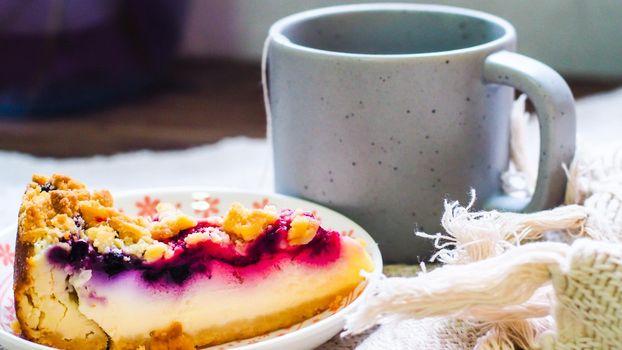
left=48, top=216, right=341, bottom=285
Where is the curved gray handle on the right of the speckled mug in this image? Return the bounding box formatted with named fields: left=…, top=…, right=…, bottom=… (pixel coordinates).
left=483, top=51, right=576, bottom=212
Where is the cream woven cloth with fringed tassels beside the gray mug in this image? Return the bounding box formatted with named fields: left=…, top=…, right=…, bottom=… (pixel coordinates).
left=344, top=98, right=622, bottom=350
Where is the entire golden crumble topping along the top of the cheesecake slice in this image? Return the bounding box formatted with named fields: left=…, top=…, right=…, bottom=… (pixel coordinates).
left=19, top=174, right=320, bottom=262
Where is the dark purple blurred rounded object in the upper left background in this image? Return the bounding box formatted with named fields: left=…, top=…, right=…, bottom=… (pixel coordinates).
left=0, top=0, right=187, bottom=115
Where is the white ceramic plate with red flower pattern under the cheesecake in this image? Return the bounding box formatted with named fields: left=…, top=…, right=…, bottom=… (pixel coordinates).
left=0, top=188, right=382, bottom=350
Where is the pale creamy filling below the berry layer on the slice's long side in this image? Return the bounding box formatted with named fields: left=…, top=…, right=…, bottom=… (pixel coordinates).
left=64, top=238, right=372, bottom=341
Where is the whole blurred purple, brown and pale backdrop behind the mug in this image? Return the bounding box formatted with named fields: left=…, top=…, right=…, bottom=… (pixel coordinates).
left=0, top=0, right=622, bottom=157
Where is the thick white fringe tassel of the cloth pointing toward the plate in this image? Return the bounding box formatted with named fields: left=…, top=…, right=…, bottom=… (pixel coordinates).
left=346, top=242, right=568, bottom=332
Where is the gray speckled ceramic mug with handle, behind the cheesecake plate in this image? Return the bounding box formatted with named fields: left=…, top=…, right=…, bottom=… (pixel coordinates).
left=264, top=4, right=575, bottom=263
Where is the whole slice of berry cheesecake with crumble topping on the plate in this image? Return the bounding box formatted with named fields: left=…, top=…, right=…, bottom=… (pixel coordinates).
left=14, top=175, right=372, bottom=350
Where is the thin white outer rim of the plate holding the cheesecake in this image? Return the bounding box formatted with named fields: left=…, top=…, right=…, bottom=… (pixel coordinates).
left=0, top=186, right=383, bottom=350
